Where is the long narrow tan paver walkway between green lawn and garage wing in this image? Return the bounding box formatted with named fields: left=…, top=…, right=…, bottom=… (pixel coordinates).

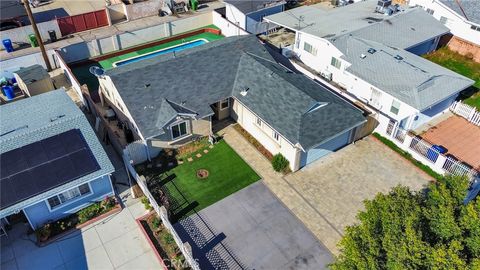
left=221, top=126, right=341, bottom=254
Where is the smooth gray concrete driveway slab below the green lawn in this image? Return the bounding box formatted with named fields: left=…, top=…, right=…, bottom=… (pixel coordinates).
left=174, top=182, right=332, bottom=269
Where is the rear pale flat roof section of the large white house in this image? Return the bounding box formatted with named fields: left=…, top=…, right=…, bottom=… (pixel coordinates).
left=265, top=1, right=449, bottom=49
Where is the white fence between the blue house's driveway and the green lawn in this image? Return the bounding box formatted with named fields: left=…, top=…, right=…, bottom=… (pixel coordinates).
left=123, top=150, right=200, bottom=270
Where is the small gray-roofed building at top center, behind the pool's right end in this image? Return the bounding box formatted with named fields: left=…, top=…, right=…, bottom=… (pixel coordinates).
left=225, top=0, right=285, bottom=34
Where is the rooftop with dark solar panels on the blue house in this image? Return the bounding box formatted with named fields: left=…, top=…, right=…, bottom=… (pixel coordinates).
left=0, top=89, right=114, bottom=216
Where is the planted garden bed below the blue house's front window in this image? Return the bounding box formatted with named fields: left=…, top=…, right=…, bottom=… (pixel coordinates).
left=35, top=196, right=122, bottom=246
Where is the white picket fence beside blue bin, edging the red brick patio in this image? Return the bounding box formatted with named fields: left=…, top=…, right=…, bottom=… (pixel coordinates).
left=384, top=127, right=480, bottom=180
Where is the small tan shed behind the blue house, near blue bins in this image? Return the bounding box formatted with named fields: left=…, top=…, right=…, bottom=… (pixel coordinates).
left=13, top=65, right=55, bottom=97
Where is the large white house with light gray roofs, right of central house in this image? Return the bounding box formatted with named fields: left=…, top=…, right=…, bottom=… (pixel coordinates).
left=265, top=1, right=474, bottom=137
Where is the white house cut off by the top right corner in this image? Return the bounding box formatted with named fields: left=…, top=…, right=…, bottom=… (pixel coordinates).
left=409, top=0, right=480, bottom=45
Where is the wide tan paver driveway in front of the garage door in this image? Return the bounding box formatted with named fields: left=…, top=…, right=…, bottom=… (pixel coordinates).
left=282, top=136, right=433, bottom=253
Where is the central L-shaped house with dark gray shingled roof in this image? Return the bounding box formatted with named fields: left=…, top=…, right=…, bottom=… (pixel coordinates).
left=94, top=35, right=366, bottom=171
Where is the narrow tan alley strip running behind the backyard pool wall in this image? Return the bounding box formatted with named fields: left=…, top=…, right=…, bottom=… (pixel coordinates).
left=0, top=1, right=225, bottom=61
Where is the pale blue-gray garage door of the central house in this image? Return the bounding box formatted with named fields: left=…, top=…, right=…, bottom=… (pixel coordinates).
left=300, top=130, right=351, bottom=167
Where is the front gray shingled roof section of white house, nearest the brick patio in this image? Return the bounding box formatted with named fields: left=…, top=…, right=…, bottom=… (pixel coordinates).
left=332, top=35, right=474, bottom=110
